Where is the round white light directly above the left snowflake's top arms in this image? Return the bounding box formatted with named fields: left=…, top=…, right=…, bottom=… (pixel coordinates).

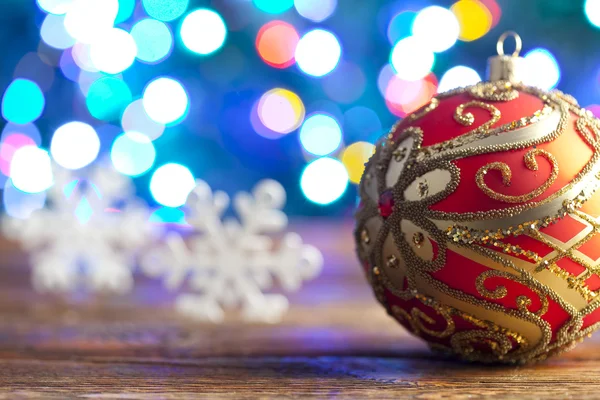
left=50, top=121, right=100, bottom=169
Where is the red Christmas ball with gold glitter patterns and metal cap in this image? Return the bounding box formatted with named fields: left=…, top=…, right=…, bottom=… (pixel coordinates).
left=355, top=34, right=600, bottom=363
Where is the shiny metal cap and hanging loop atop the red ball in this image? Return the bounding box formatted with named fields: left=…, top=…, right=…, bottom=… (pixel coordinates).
left=487, top=31, right=525, bottom=83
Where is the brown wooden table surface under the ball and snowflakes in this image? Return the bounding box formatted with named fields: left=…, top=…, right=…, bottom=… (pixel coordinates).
left=0, top=221, right=600, bottom=399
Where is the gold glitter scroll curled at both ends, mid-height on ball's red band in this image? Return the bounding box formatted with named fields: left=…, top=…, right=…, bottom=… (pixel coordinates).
left=475, top=149, right=558, bottom=203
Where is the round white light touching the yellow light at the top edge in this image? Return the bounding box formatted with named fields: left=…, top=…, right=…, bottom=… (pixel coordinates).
left=412, top=6, right=460, bottom=52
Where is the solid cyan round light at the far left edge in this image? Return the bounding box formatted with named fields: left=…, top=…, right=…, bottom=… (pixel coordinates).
left=2, top=79, right=46, bottom=125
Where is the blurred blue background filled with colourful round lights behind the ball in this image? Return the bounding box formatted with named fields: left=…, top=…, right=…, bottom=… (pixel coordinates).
left=0, top=0, right=600, bottom=222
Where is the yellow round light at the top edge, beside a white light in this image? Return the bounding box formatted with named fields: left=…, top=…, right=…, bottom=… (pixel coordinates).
left=450, top=0, right=492, bottom=42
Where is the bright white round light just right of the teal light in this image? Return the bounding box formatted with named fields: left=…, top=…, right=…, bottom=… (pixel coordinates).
left=142, top=78, right=189, bottom=124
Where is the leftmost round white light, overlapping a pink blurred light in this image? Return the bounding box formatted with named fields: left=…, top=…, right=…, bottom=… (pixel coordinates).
left=10, top=146, right=53, bottom=193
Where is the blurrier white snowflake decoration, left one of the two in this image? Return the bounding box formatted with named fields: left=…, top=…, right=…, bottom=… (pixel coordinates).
left=4, top=166, right=151, bottom=293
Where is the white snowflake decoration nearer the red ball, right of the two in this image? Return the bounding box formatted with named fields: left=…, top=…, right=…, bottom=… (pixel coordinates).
left=142, top=180, right=323, bottom=323
